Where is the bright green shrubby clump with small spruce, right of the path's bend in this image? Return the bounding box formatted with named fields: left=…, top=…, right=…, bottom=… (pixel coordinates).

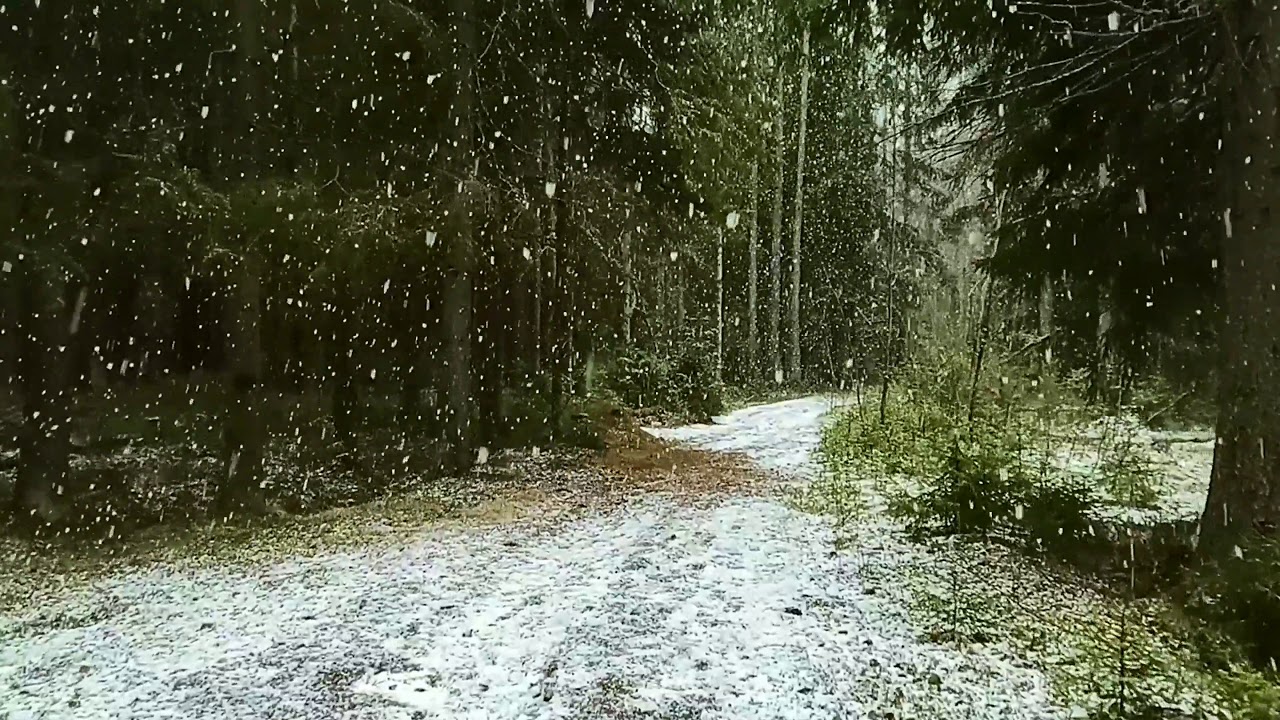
left=813, top=391, right=1158, bottom=553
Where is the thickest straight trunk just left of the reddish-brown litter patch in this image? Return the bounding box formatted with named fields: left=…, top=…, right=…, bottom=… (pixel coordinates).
left=443, top=0, right=475, bottom=471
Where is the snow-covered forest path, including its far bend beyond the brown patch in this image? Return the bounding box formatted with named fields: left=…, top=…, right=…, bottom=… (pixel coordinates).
left=0, top=398, right=1065, bottom=720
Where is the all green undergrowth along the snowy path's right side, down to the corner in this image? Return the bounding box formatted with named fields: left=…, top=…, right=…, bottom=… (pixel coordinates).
left=800, top=391, right=1280, bottom=720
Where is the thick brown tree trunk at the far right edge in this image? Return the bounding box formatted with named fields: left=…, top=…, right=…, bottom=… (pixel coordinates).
left=1201, top=0, right=1280, bottom=548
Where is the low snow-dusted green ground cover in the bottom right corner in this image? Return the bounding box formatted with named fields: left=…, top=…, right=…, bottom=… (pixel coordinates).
left=879, top=538, right=1280, bottom=720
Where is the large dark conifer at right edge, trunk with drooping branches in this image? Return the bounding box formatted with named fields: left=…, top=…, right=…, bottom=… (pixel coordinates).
left=890, top=0, right=1280, bottom=555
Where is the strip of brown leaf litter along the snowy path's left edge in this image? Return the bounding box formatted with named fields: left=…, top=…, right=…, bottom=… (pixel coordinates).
left=0, top=419, right=768, bottom=611
